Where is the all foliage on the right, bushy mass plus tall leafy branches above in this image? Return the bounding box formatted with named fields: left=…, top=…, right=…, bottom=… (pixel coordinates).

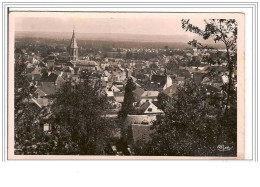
left=133, top=19, right=237, bottom=156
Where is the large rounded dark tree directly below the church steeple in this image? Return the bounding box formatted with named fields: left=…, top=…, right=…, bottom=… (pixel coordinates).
left=49, top=81, right=112, bottom=155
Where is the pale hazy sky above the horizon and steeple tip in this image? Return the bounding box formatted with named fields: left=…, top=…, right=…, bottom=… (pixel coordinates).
left=11, top=12, right=216, bottom=35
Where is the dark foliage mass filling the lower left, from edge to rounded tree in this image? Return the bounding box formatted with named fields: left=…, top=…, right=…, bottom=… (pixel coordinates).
left=15, top=60, right=113, bottom=155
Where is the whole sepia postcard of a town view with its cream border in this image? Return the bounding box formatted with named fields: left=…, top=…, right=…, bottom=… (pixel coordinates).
left=8, top=11, right=245, bottom=159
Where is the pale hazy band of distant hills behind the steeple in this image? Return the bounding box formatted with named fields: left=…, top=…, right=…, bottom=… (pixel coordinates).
left=15, top=31, right=223, bottom=48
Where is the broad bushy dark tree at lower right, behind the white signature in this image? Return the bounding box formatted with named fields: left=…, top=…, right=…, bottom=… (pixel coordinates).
left=134, top=81, right=236, bottom=156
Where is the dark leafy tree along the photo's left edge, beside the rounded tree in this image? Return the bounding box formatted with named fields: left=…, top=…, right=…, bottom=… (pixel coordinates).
left=14, top=62, right=47, bottom=154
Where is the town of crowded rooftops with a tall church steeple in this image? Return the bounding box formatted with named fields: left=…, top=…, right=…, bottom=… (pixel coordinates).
left=15, top=19, right=236, bottom=155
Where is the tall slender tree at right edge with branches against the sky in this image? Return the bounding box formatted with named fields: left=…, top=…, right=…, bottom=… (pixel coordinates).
left=182, top=19, right=237, bottom=111
